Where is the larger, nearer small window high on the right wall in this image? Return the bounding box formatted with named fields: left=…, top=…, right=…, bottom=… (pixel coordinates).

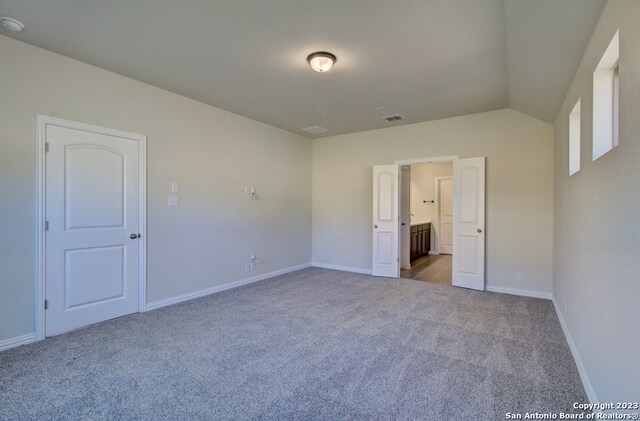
left=593, top=31, right=620, bottom=161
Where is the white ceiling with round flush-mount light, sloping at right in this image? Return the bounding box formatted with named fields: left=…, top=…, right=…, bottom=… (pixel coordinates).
left=0, top=0, right=606, bottom=137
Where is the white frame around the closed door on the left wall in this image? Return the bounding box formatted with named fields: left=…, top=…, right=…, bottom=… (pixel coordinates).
left=35, top=114, right=147, bottom=340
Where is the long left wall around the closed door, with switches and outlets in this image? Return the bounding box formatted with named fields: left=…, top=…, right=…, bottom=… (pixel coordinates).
left=0, top=36, right=311, bottom=341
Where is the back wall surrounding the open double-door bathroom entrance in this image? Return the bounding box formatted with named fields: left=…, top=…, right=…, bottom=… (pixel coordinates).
left=313, top=110, right=553, bottom=296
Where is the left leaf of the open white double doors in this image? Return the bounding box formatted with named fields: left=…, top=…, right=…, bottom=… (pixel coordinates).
left=371, top=165, right=400, bottom=278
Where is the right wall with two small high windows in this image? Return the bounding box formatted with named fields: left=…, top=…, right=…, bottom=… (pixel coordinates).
left=554, top=0, right=640, bottom=402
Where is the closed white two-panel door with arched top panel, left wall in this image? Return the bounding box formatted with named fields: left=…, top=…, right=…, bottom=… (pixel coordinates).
left=45, top=124, right=142, bottom=336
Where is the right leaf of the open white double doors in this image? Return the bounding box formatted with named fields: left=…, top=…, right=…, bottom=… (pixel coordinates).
left=451, top=157, right=485, bottom=291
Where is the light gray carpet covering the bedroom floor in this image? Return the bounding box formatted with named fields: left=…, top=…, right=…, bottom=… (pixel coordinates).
left=0, top=268, right=587, bottom=420
